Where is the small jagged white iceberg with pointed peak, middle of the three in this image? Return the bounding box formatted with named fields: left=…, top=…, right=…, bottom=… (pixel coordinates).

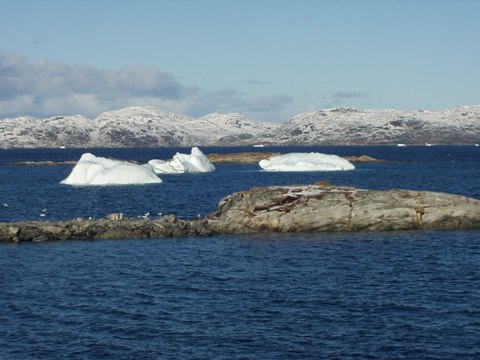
left=148, top=147, right=215, bottom=174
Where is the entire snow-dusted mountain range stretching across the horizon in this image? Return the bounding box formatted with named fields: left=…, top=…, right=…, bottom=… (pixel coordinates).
left=0, top=105, right=480, bottom=148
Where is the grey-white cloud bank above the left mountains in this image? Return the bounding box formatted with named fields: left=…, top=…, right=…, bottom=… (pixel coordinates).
left=0, top=50, right=293, bottom=120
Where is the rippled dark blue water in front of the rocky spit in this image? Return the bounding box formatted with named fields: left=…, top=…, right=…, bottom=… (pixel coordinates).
left=0, top=231, right=480, bottom=359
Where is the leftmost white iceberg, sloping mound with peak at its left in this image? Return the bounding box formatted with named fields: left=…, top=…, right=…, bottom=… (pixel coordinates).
left=60, top=153, right=162, bottom=185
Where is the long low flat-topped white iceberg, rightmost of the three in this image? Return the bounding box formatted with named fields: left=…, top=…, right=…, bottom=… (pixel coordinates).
left=258, top=152, right=355, bottom=171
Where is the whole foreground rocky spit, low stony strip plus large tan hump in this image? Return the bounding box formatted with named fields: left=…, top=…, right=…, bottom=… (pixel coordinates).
left=0, top=184, right=480, bottom=242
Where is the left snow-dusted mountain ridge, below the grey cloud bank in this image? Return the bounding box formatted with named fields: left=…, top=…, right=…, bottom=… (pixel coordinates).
left=0, top=107, right=280, bottom=148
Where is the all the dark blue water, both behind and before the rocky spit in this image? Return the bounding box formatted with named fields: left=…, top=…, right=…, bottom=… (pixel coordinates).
left=0, top=147, right=480, bottom=359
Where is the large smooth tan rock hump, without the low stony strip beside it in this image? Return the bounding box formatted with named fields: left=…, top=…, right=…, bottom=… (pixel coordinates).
left=212, top=185, right=480, bottom=234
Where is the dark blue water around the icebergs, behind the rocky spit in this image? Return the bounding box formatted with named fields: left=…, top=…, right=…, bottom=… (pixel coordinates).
left=0, top=146, right=480, bottom=221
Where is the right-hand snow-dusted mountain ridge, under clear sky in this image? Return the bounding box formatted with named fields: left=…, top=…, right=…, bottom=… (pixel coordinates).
left=258, top=105, right=480, bottom=145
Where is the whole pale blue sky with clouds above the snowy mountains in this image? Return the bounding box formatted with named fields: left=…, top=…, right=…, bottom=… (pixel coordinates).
left=0, top=0, right=480, bottom=123
